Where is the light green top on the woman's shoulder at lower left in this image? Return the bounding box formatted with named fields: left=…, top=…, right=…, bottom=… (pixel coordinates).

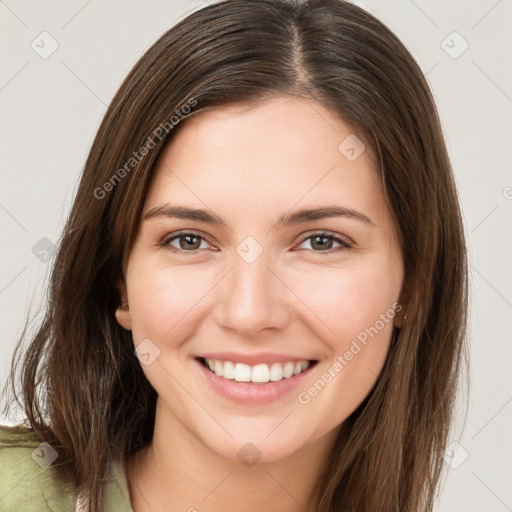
left=0, top=425, right=134, bottom=512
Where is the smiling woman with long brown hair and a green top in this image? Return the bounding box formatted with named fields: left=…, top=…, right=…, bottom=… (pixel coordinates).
left=0, top=0, right=467, bottom=512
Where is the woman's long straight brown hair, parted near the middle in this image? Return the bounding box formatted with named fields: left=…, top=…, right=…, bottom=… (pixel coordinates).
left=3, top=0, right=468, bottom=512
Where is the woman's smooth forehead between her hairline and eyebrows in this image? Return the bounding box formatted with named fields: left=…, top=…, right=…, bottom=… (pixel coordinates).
left=145, top=96, right=383, bottom=222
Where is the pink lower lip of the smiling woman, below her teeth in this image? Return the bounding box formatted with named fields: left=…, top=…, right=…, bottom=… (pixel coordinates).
left=195, top=359, right=316, bottom=405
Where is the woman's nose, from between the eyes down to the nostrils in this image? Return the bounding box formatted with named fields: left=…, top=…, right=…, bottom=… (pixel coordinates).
left=215, top=252, right=293, bottom=338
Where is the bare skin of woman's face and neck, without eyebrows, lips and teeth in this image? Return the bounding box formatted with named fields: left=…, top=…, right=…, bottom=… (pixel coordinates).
left=116, top=96, right=404, bottom=512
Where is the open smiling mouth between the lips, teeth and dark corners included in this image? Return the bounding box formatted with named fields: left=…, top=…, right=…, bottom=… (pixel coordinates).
left=196, top=357, right=318, bottom=386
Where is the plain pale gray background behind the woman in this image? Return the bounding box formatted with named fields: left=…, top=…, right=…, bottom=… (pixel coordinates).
left=0, top=0, right=512, bottom=512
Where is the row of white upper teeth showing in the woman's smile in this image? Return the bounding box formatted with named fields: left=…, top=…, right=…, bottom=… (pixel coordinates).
left=205, top=358, right=310, bottom=383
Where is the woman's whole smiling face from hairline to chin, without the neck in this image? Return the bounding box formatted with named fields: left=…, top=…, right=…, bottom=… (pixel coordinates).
left=116, top=96, right=403, bottom=461
